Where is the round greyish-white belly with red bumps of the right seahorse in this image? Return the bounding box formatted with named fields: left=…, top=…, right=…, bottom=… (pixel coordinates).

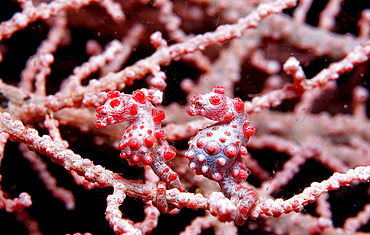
left=185, top=116, right=249, bottom=181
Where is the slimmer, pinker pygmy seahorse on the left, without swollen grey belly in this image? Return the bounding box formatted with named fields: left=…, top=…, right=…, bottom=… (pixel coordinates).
left=95, top=91, right=182, bottom=189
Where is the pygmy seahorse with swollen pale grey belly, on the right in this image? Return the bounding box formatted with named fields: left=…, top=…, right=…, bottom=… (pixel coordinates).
left=185, top=87, right=258, bottom=223
